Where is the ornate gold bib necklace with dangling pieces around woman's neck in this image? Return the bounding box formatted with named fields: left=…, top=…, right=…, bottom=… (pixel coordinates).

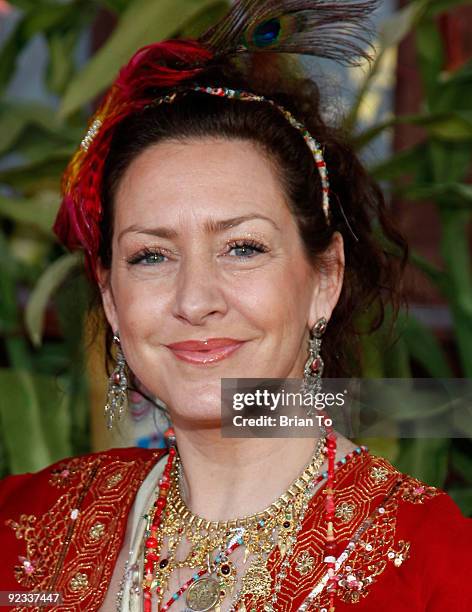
left=150, top=437, right=326, bottom=612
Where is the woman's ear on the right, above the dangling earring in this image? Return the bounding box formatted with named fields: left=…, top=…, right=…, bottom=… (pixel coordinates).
left=308, top=232, right=345, bottom=329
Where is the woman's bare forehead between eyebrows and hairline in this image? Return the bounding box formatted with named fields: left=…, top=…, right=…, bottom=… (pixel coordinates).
left=115, top=138, right=290, bottom=231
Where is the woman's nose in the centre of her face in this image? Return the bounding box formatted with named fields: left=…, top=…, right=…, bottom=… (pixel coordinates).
left=173, top=252, right=227, bottom=325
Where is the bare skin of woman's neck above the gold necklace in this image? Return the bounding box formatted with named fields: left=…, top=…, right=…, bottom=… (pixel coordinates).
left=168, top=425, right=355, bottom=521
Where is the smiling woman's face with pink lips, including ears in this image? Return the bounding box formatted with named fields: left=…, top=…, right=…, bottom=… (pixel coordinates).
left=98, top=138, right=344, bottom=425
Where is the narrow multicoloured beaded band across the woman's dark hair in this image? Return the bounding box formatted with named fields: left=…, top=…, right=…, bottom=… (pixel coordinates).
left=153, top=85, right=330, bottom=225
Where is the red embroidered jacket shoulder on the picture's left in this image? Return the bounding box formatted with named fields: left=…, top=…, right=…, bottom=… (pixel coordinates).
left=0, top=448, right=167, bottom=597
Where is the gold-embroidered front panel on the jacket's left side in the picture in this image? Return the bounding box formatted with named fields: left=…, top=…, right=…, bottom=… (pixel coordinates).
left=6, top=451, right=165, bottom=612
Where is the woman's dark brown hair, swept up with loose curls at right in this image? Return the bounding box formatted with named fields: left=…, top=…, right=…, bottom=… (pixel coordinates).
left=94, top=65, right=408, bottom=377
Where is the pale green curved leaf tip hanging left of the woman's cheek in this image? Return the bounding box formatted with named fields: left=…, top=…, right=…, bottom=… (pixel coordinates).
left=25, top=253, right=80, bottom=346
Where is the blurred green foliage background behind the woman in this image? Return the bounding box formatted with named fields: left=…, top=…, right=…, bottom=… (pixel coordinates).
left=0, top=0, right=472, bottom=515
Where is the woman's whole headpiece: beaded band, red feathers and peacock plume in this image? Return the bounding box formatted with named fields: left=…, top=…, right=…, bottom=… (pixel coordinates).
left=53, top=0, right=378, bottom=280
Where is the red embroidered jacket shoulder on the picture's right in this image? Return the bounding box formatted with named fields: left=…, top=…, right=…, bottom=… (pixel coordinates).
left=320, top=452, right=472, bottom=612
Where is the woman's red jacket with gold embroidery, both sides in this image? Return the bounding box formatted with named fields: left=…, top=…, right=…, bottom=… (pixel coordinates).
left=0, top=448, right=472, bottom=612
